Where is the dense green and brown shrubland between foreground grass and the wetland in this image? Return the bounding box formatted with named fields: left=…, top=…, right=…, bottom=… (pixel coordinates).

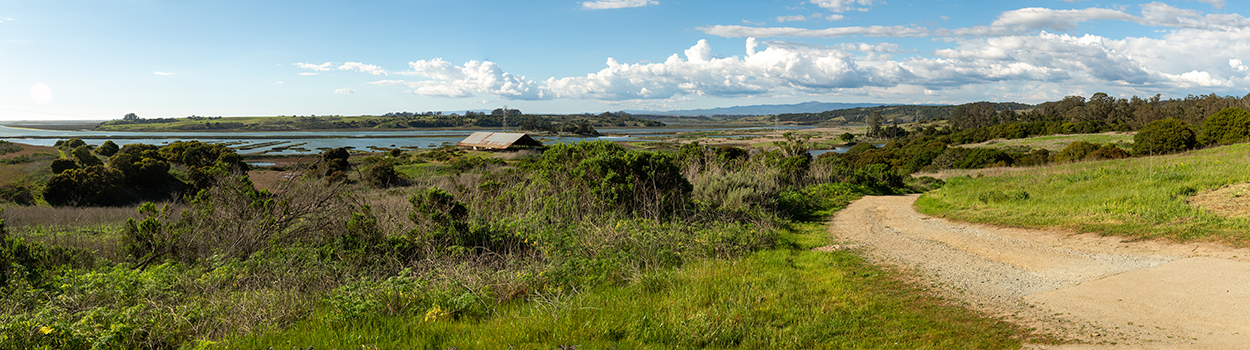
left=0, top=138, right=901, bottom=349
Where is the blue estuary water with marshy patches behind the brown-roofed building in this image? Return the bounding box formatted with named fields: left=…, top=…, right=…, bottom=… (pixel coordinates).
left=0, top=125, right=813, bottom=155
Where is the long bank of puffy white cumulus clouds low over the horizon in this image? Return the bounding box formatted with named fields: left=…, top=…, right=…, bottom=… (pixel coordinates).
left=320, top=24, right=1250, bottom=104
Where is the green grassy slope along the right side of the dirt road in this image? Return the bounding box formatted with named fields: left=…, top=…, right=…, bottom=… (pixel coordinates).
left=916, top=144, right=1250, bottom=246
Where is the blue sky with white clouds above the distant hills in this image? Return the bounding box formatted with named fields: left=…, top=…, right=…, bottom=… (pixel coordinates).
left=0, top=0, right=1250, bottom=120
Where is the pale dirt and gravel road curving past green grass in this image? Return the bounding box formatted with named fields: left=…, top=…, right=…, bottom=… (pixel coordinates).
left=830, top=195, right=1250, bottom=349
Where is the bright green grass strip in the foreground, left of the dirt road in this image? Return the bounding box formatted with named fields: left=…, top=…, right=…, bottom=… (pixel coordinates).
left=219, top=224, right=1026, bottom=349
